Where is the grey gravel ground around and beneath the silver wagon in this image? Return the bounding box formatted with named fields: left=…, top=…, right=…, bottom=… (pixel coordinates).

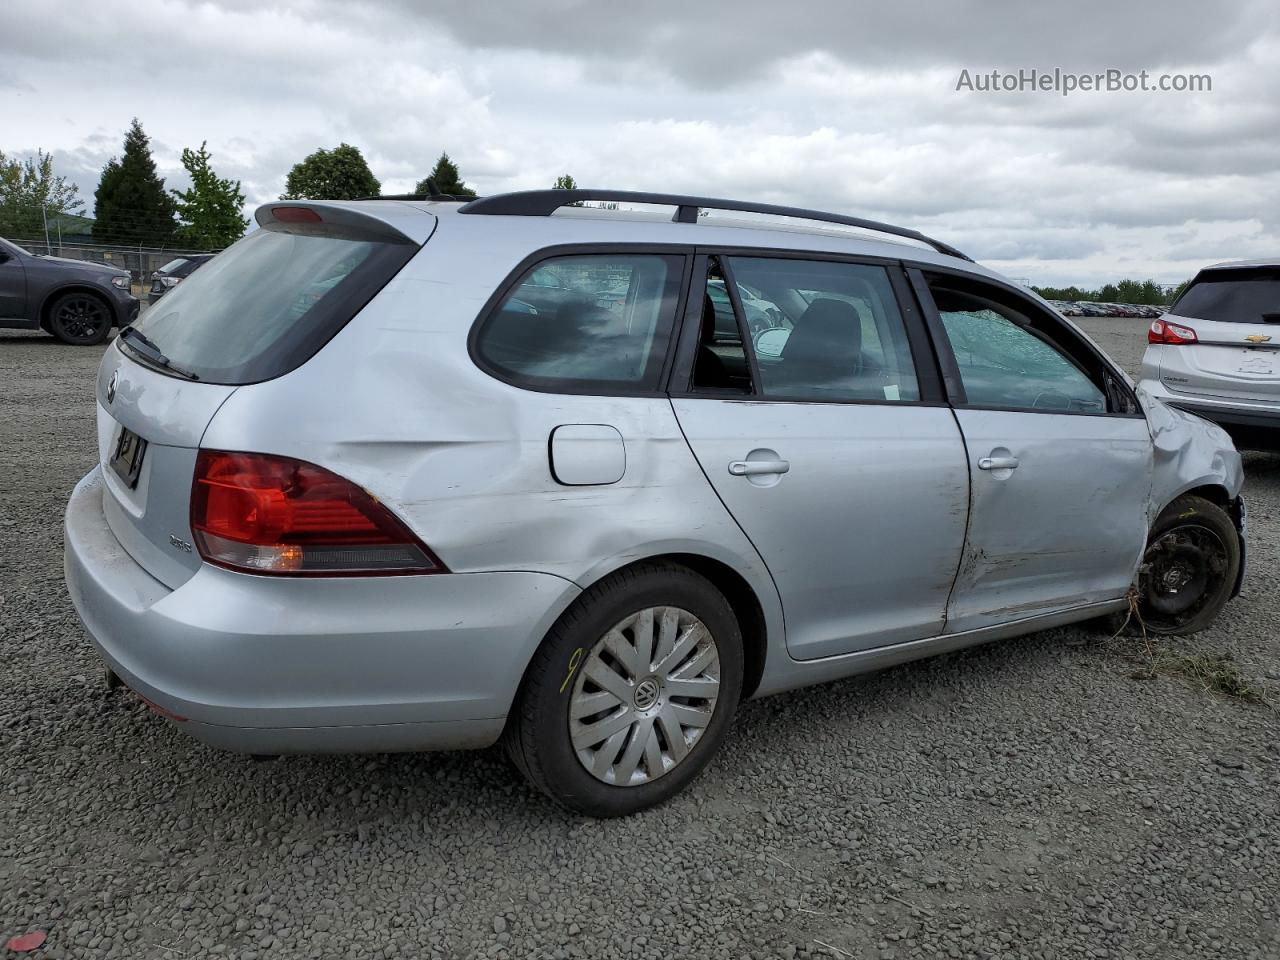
left=0, top=320, right=1280, bottom=960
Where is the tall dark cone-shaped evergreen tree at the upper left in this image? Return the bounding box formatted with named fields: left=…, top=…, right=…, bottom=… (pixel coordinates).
left=93, top=118, right=178, bottom=247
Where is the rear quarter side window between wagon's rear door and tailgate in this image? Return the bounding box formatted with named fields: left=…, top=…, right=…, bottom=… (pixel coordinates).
left=475, top=253, right=684, bottom=393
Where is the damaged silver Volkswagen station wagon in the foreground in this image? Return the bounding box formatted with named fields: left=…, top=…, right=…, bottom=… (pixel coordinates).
left=65, top=191, right=1245, bottom=815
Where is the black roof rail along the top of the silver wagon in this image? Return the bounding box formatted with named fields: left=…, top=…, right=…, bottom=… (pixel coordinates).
left=458, top=189, right=973, bottom=262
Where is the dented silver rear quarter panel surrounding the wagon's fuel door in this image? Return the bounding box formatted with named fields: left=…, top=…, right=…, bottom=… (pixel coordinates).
left=204, top=218, right=782, bottom=644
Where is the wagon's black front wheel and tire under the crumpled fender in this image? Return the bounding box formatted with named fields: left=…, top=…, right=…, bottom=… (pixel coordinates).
left=1128, top=494, right=1240, bottom=635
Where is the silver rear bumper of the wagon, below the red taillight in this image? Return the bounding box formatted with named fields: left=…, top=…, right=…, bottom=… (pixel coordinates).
left=64, top=468, right=579, bottom=754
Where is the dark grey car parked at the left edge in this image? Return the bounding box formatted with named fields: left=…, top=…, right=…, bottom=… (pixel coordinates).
left=0, top=239, right=138, bottom=346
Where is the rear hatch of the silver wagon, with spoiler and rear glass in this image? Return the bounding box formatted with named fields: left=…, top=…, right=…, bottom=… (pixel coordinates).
left=97, top=201, right=435, bottom=588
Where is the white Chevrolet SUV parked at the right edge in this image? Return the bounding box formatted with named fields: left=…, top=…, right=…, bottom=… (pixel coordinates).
left=1140, top=260, right=1280, bottom=448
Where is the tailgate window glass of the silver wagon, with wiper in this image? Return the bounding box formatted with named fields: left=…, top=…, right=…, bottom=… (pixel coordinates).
left=124, top=229, right=417, bottom=384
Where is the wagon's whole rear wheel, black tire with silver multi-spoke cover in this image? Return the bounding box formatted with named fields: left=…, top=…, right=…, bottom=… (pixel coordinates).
left=504, top=563, right=742, bottom=817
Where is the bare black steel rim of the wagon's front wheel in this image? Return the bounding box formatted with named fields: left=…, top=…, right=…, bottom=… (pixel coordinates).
left=1140, top=524, right=1228, bottom=630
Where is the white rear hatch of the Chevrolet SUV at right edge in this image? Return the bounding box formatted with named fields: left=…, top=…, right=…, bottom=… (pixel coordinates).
left=1160, top=266, right=1280, bottom=404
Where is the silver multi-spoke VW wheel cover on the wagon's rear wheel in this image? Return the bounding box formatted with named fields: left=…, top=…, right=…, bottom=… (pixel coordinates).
left=568, top=607, right=721, bottom=787
